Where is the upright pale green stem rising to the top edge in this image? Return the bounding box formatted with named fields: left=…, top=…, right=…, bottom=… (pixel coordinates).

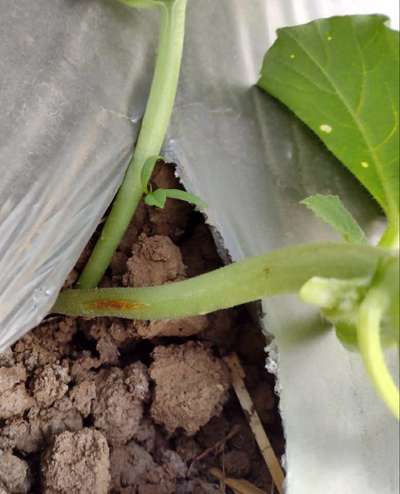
left=79, top=0, right=187, bottom=288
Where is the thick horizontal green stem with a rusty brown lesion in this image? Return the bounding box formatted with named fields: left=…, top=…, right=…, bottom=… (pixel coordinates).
left=53, top=243, right=389, bottom=320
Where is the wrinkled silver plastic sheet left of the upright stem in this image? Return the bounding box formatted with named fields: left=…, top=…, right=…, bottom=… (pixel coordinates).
left=0, top=0, right=157, bottom=350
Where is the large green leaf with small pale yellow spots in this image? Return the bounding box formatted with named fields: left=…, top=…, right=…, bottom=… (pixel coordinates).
left=258, top=15, right=399, bottom=242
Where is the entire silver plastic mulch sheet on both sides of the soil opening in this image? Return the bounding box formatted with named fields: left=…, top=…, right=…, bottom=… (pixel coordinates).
left=0, top=0, right=399, bottom=494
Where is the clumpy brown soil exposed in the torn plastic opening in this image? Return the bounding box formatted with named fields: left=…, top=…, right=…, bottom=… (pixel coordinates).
left=0, top=165, right=284, bottom=494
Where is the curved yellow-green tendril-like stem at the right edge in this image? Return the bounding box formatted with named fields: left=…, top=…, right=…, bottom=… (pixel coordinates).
left=357, top=289, right=400, bottom=419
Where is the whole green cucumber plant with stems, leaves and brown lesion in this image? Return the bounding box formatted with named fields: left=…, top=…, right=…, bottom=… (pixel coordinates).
left=53, top=5, right=400, bottom=418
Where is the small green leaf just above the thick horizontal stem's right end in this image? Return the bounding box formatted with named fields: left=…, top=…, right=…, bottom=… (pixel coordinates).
left=301, top=194, right=367, bottom=244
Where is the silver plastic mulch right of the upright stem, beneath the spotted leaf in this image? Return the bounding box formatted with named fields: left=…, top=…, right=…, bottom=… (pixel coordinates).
left=171, top=0, right=399, bottom=494
